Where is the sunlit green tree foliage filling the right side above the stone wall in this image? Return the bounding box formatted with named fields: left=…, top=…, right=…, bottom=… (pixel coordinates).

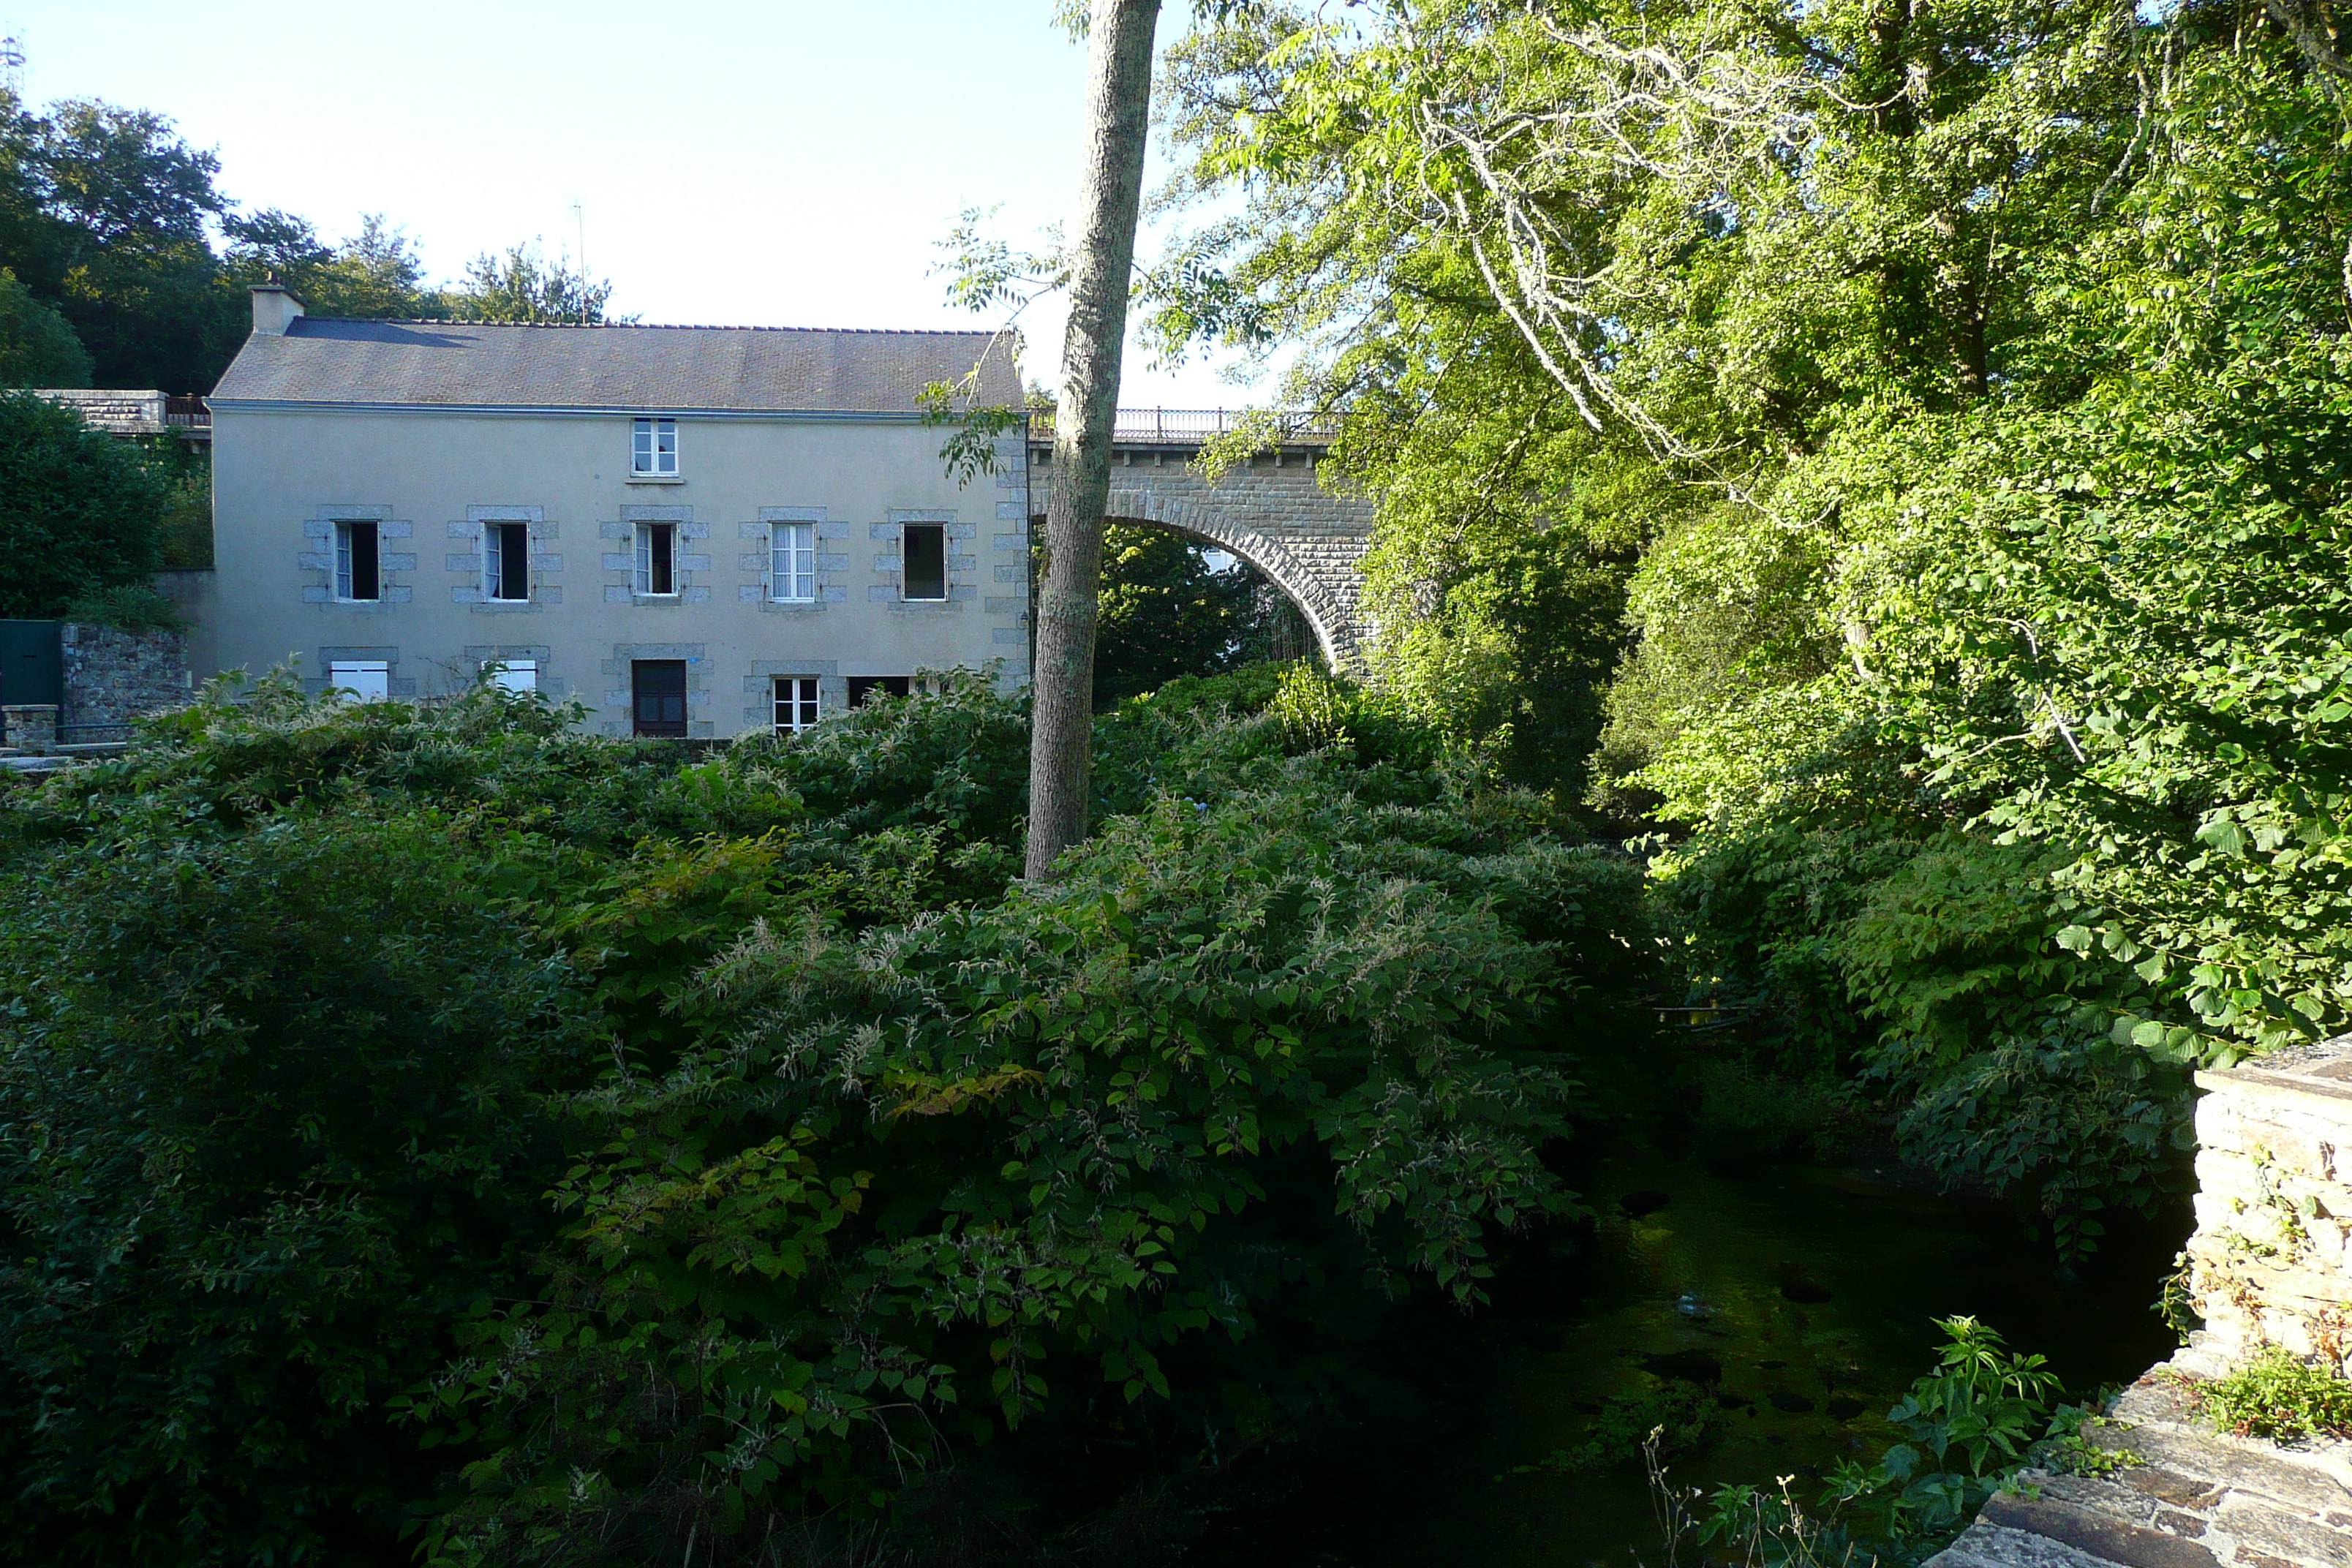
left=1155, top=0, right=2352, bottom=1243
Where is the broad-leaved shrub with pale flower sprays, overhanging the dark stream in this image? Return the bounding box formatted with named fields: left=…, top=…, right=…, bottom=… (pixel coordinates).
left=414, top=799, right=1640, bottom=1561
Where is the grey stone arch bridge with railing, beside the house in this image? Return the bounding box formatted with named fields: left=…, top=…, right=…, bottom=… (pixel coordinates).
left=1025, top=409, right=1373, bottom=670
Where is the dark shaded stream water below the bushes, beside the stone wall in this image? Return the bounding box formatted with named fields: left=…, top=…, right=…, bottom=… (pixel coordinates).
left=1183, top=1152, right=2187, bottom=1568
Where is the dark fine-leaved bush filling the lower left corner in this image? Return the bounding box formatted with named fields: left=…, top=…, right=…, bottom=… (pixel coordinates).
left=0, top=811, right=600, bottom=1564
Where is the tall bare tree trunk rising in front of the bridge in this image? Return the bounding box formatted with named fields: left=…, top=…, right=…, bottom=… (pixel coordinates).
left=1028, top=0, right=1159, bottom=879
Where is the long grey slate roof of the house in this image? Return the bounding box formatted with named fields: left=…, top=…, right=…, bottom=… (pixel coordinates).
left=211, top=315, right=1021, bottom=414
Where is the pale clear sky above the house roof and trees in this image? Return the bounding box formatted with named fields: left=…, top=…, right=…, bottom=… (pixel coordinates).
left=13, top=0, right=1251, bottom=407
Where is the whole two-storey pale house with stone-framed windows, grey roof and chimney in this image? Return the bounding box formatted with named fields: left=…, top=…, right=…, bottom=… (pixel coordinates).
left=209, top=284, right=1030, bottom=736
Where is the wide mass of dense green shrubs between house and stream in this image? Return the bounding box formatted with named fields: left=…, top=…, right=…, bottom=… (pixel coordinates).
left=0, top=672, right=1648, bottom=1564
